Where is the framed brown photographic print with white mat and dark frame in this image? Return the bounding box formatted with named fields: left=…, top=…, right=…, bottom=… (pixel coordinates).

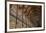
left=6, top=1, right=45, bottom=32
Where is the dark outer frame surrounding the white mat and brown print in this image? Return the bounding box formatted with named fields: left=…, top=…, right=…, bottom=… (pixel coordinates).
left=5, top=1, right=45, bottom=32
